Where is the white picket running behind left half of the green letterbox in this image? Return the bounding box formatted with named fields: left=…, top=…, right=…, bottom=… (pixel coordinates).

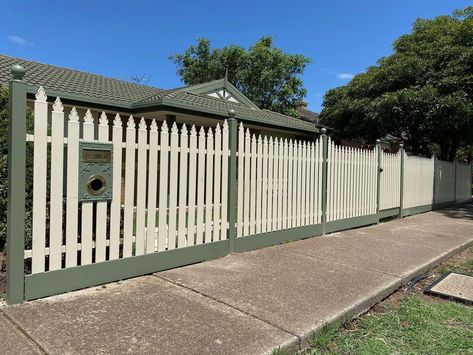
left=81, top=110, right=94, bottom=265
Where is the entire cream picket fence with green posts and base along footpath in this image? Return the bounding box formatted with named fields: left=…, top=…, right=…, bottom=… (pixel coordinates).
left=7, top=80, right=471, bottom=303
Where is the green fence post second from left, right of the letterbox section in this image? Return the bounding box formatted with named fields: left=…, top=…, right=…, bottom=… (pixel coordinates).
left=227, top=110, right=238, bottom=253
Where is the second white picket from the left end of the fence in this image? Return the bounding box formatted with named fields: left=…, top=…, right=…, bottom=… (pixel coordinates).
left=49, top=97, right=64, bottom=271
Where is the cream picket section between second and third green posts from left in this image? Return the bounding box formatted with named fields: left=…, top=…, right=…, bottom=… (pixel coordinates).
left=237, top=124, right=322, bottom=237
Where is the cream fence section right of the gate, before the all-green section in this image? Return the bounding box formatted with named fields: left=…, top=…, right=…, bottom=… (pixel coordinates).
left=402, top=153, right=434, bottom=208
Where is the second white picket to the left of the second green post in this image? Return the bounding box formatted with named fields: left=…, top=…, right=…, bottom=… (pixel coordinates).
left=212, top=124, right=222, bottom=242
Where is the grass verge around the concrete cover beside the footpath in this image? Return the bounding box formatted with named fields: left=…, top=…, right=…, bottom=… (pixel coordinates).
left=273, top=248, right=473, bottom=355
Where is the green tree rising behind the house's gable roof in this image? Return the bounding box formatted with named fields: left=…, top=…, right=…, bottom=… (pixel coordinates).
left=170, top=37, right=310, bottom=115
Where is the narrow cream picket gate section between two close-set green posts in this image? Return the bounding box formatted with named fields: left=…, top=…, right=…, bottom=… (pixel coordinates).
left=379, top=152, right=401, bottom=210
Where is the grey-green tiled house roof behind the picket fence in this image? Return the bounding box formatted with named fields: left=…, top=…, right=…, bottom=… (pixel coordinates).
left=0, top=55, right=315, bottom=131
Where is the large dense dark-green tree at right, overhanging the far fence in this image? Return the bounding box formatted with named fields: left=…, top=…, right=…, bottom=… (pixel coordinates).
left=320, top=7, right=473, bottom=160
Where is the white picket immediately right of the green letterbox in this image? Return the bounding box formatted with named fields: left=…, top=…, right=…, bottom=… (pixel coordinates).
left=109, top=113, right=123, bottom=260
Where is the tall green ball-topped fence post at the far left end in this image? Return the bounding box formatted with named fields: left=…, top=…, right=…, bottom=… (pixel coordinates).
left=6, top=65, right=26, bottom=304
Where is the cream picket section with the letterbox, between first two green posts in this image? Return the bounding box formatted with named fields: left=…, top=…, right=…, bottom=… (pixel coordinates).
left=25, top=88, right=229, bottom=274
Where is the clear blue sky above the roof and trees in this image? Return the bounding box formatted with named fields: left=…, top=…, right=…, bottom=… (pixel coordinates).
left=0, top=0, right=471, bottom=111
